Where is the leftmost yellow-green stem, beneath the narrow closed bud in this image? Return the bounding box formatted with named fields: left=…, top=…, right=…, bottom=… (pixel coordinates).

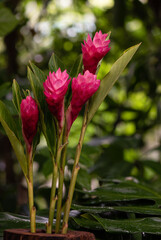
left=27, top=145, right=36, bottom=233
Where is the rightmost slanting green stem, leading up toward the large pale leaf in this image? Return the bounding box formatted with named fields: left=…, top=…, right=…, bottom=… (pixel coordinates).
left=62, top=102, right=89, bottom=234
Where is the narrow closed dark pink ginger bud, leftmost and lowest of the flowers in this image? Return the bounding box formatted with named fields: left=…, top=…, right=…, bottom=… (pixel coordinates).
left=20, top=96, right=39, bottom=152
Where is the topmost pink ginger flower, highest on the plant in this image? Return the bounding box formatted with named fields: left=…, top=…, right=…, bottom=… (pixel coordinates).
left=82, top=31, right=110, bottom=74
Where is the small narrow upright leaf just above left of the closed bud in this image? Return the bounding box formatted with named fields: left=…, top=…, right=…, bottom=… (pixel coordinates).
left=12, top=79, right=22, bottom=113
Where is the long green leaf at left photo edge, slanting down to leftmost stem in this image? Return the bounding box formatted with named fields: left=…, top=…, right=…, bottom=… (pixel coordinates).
left=0, top=101, right=27, bottom=177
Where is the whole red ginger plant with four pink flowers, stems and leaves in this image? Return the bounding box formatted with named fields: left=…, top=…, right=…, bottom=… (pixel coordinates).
left=0, top=31, right=140, bottom=234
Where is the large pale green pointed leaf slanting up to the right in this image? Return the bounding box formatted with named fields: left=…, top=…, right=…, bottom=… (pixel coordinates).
left=87, top=44, right=140, bottom=123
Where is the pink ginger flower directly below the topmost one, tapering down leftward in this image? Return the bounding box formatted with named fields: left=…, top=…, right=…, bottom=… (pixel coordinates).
left=66, top=70, right=100, bottom=133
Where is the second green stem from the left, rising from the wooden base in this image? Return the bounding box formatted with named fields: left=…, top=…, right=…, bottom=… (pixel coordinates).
left=46, top=130, right=63, bottom=233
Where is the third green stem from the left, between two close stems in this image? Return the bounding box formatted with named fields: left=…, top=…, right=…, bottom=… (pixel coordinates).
left=55, top=131, right=68, bottom=233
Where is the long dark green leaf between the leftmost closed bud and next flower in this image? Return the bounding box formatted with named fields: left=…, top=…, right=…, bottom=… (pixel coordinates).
left=28, top=63, right=56, bottom=154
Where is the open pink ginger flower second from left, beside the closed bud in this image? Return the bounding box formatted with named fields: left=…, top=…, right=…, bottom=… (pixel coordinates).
left=43, top=68, right=71, bottom=129
